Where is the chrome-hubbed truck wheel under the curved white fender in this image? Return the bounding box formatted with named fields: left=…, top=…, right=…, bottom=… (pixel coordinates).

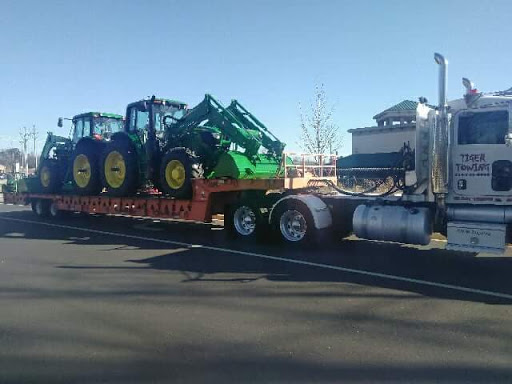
left=271, top=200, right=329, bottom=246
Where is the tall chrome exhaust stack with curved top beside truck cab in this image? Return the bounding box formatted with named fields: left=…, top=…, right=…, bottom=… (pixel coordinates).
left=431, top=53, right=448, bottom=198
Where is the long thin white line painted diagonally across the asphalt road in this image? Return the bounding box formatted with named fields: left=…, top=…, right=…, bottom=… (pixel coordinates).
left=0, top=216, right=512, bottom=300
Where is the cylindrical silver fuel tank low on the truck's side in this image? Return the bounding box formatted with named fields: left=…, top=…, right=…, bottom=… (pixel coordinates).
left=352, top=204, right=432, bottom=245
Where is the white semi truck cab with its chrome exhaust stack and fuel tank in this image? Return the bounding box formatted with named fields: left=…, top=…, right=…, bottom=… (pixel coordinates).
left=340, top=53, right=512, bottom=253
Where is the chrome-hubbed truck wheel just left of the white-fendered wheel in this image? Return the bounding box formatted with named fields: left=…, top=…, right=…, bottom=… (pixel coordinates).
left=224, top=201, right=270, bottom=240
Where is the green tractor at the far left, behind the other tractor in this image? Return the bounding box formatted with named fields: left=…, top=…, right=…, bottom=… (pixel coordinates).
left=36, top=112, right=124, bottom=195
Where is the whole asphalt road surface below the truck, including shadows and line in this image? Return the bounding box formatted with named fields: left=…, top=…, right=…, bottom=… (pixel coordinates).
left=0, top=205, right=512, bottom=384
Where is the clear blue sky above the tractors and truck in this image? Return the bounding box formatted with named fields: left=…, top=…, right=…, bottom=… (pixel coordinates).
left=0, top=0, right=512, bottom=154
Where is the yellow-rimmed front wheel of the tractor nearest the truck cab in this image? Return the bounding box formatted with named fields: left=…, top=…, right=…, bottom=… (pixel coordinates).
left=159, top=148, right=203, bottom=199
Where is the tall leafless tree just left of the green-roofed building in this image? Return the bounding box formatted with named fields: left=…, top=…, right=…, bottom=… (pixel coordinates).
left=297, top=84, right=342, bottom=154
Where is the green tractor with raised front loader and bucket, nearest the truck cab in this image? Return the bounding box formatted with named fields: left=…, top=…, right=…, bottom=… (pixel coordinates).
left=102, top=95, right=284, bottom=198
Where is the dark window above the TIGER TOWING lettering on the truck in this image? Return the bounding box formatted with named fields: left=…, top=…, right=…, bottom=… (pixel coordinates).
left=458, top=111, right=508, bottom=145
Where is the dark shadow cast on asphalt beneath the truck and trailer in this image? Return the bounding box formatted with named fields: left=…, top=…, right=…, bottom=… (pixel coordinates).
left=0, top=211, right=512, bottom=304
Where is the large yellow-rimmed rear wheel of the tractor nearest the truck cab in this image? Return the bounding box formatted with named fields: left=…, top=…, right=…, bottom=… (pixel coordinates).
left=101, top=140, right=139, bottom=196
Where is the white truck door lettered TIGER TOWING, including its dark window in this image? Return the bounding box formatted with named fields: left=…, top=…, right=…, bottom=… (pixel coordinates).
left=451, top=107, right=512, bottom=204
